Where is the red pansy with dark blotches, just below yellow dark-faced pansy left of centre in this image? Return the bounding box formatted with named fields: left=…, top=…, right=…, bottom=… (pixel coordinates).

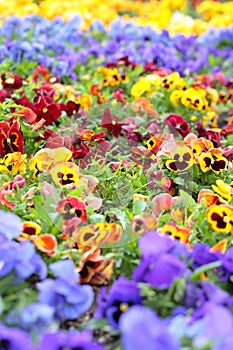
left=56, top=196, right=87, bottom=222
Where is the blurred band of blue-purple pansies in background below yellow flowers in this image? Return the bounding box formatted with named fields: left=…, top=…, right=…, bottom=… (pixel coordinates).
left=0, top=14, right=233, bottom=82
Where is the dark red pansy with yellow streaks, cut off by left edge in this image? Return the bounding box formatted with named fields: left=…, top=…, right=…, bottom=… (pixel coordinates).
left=0, top=119, right=24, bottom=156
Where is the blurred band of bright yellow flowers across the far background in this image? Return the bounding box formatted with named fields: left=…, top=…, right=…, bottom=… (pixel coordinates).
left=0, top=0, right=233, bottom=35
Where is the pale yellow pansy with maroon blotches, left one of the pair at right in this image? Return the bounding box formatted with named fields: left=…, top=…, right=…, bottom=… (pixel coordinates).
left=165, top=146, right=194, bottom=172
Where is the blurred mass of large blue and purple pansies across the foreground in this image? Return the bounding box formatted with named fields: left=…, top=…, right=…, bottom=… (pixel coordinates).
left=3, top=210, right=233, bottom=350
